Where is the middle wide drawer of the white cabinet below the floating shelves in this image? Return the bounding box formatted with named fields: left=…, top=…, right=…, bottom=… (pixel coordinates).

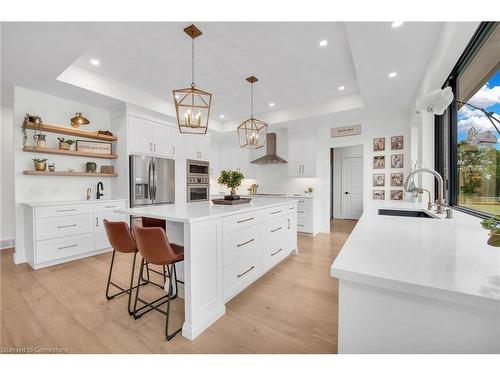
left=36, top=215, right=94, bottom=240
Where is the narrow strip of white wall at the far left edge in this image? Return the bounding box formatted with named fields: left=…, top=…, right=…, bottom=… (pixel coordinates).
left=0, top=106, right=15, bottom=248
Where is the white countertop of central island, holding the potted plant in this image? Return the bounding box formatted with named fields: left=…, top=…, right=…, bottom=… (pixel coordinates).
left=116, top=198, right=296, bottom=223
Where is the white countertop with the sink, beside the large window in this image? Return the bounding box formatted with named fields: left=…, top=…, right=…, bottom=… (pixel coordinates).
left=331, top=202, right=500, bottom=312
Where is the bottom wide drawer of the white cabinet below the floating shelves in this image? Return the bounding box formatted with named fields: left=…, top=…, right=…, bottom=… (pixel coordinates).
left=35, top=233, right=94, bottom=263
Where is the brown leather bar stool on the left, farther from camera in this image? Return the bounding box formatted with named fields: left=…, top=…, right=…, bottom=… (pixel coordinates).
left=103, top=219, right=147, bottom=315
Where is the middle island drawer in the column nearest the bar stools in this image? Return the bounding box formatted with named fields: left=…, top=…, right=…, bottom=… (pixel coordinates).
left=223, top=225, right=262, bottom=266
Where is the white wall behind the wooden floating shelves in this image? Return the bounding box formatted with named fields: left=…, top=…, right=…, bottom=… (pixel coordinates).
left=13, top=87, right=114, bottom=263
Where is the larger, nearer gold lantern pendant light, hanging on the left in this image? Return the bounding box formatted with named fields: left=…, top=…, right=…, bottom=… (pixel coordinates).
left=173, top=25, right=212, bottom=134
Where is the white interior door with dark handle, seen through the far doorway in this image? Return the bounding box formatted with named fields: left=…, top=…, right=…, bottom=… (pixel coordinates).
left=342, top=156, right=363, bottom=219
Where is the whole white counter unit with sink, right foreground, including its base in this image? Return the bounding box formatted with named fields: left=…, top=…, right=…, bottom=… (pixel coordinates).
left=331, top=202, right=500, bottom=353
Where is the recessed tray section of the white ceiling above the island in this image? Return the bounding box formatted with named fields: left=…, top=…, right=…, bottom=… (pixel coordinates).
left=71, top=22, right=358, bottom=120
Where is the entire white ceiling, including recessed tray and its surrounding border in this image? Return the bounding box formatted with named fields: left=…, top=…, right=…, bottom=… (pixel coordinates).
left=2, top=22, right=442, bottom=125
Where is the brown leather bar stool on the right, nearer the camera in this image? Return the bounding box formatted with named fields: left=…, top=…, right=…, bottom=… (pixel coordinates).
left=134, top=227, right=184, bottom=341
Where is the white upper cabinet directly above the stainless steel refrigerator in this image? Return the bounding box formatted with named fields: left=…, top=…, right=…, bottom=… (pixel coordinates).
left=127, top=116, right=174, bottom=157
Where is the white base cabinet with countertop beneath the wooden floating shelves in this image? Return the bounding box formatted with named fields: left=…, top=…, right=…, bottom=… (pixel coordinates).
left=24, top=199, right=127, bottom=269
